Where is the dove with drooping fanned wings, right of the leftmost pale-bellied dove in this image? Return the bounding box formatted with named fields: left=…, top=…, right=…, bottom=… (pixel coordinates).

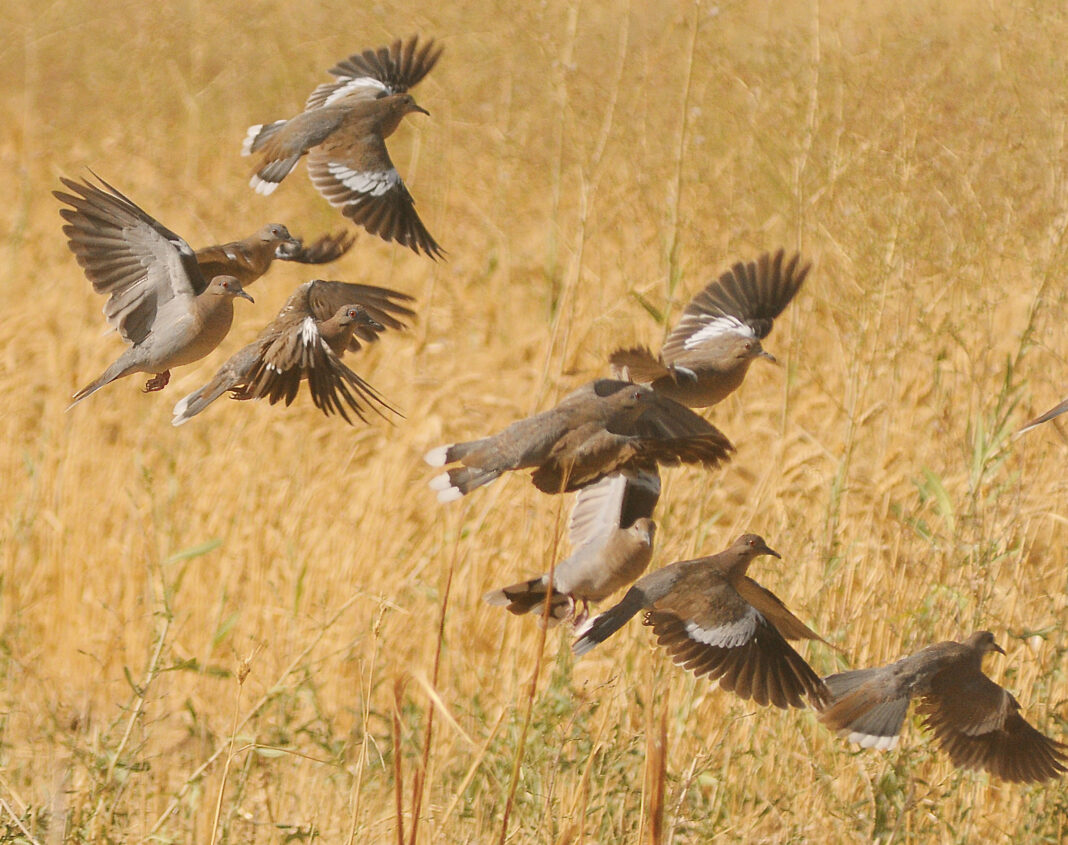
left=171, top=280, right=414, bottom=425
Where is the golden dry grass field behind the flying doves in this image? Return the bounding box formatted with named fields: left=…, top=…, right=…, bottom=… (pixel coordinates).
left=0, top=0, right=1068, bottom=845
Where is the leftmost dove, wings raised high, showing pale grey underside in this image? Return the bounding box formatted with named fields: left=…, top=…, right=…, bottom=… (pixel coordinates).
left=52, top=177, right=252, bottom=408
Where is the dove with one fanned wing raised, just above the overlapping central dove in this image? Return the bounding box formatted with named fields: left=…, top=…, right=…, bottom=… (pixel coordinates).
left=609, top=250, right=811, bottom=408
